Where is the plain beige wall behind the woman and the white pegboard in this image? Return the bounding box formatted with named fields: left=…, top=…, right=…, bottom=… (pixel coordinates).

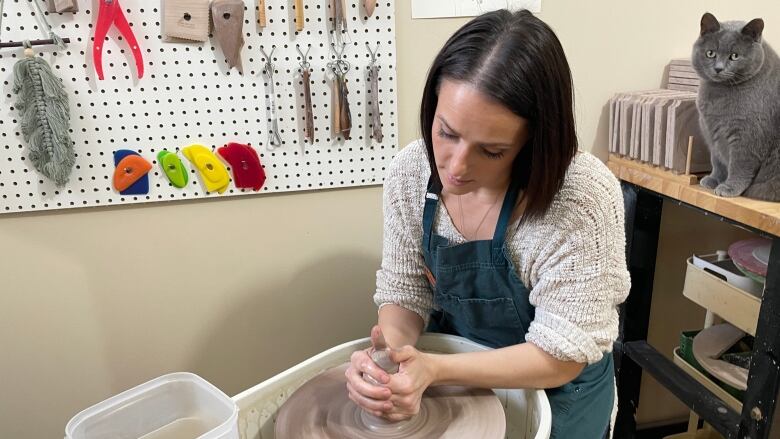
left=0, top=0, right=780, bottom=438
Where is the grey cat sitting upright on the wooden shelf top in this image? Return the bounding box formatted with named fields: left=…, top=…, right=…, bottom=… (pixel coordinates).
left=692, top=13, right=780, bottom=201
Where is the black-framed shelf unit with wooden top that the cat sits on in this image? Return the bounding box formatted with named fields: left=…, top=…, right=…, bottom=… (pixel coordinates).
left=609, top=159, right=780, bottom=439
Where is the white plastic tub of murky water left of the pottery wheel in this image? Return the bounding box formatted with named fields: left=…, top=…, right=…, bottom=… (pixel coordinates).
left=65, top=373, right=239, bottom=439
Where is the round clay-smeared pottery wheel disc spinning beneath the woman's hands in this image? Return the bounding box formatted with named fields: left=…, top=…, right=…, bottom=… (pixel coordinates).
left=275, top=364, right=506, bottom=439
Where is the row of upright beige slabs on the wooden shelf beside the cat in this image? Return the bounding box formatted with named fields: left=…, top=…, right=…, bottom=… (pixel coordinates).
left=609, top=60, right=710, bottom=173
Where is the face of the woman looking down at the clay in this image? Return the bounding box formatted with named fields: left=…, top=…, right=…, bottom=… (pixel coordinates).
left=432, top=79, right=529, bottom=195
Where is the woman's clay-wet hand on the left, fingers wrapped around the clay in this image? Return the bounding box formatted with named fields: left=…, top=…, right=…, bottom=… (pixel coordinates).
left=345, top=326, right=393, bottom=416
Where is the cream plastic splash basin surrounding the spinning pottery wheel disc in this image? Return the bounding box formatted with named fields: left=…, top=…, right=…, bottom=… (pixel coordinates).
left=233, top=334, right=552, bottom=439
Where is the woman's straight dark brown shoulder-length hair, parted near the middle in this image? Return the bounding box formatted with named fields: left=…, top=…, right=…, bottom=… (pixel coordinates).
left=420, top=10, right=577, bottom=222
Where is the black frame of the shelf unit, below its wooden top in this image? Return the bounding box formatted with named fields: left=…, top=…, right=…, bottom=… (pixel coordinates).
left=614, top=181, right=780, bottom=439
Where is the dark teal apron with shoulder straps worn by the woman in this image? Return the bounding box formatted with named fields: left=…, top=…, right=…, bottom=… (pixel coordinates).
left=423, top=177, right=615, bottom=439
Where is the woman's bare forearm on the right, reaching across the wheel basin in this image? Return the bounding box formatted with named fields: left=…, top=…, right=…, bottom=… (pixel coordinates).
left=425, top=343, right=585, bottom=389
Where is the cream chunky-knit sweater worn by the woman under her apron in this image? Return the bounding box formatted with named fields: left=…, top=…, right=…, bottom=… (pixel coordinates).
left=374, top=141, right=630, bottom=363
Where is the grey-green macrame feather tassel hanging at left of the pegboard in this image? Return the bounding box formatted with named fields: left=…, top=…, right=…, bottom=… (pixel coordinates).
left=13, top=48, right=76, bottom=186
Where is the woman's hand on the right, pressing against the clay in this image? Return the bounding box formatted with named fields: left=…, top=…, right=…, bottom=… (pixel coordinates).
left=383, top=346, right=436, bottom=421
